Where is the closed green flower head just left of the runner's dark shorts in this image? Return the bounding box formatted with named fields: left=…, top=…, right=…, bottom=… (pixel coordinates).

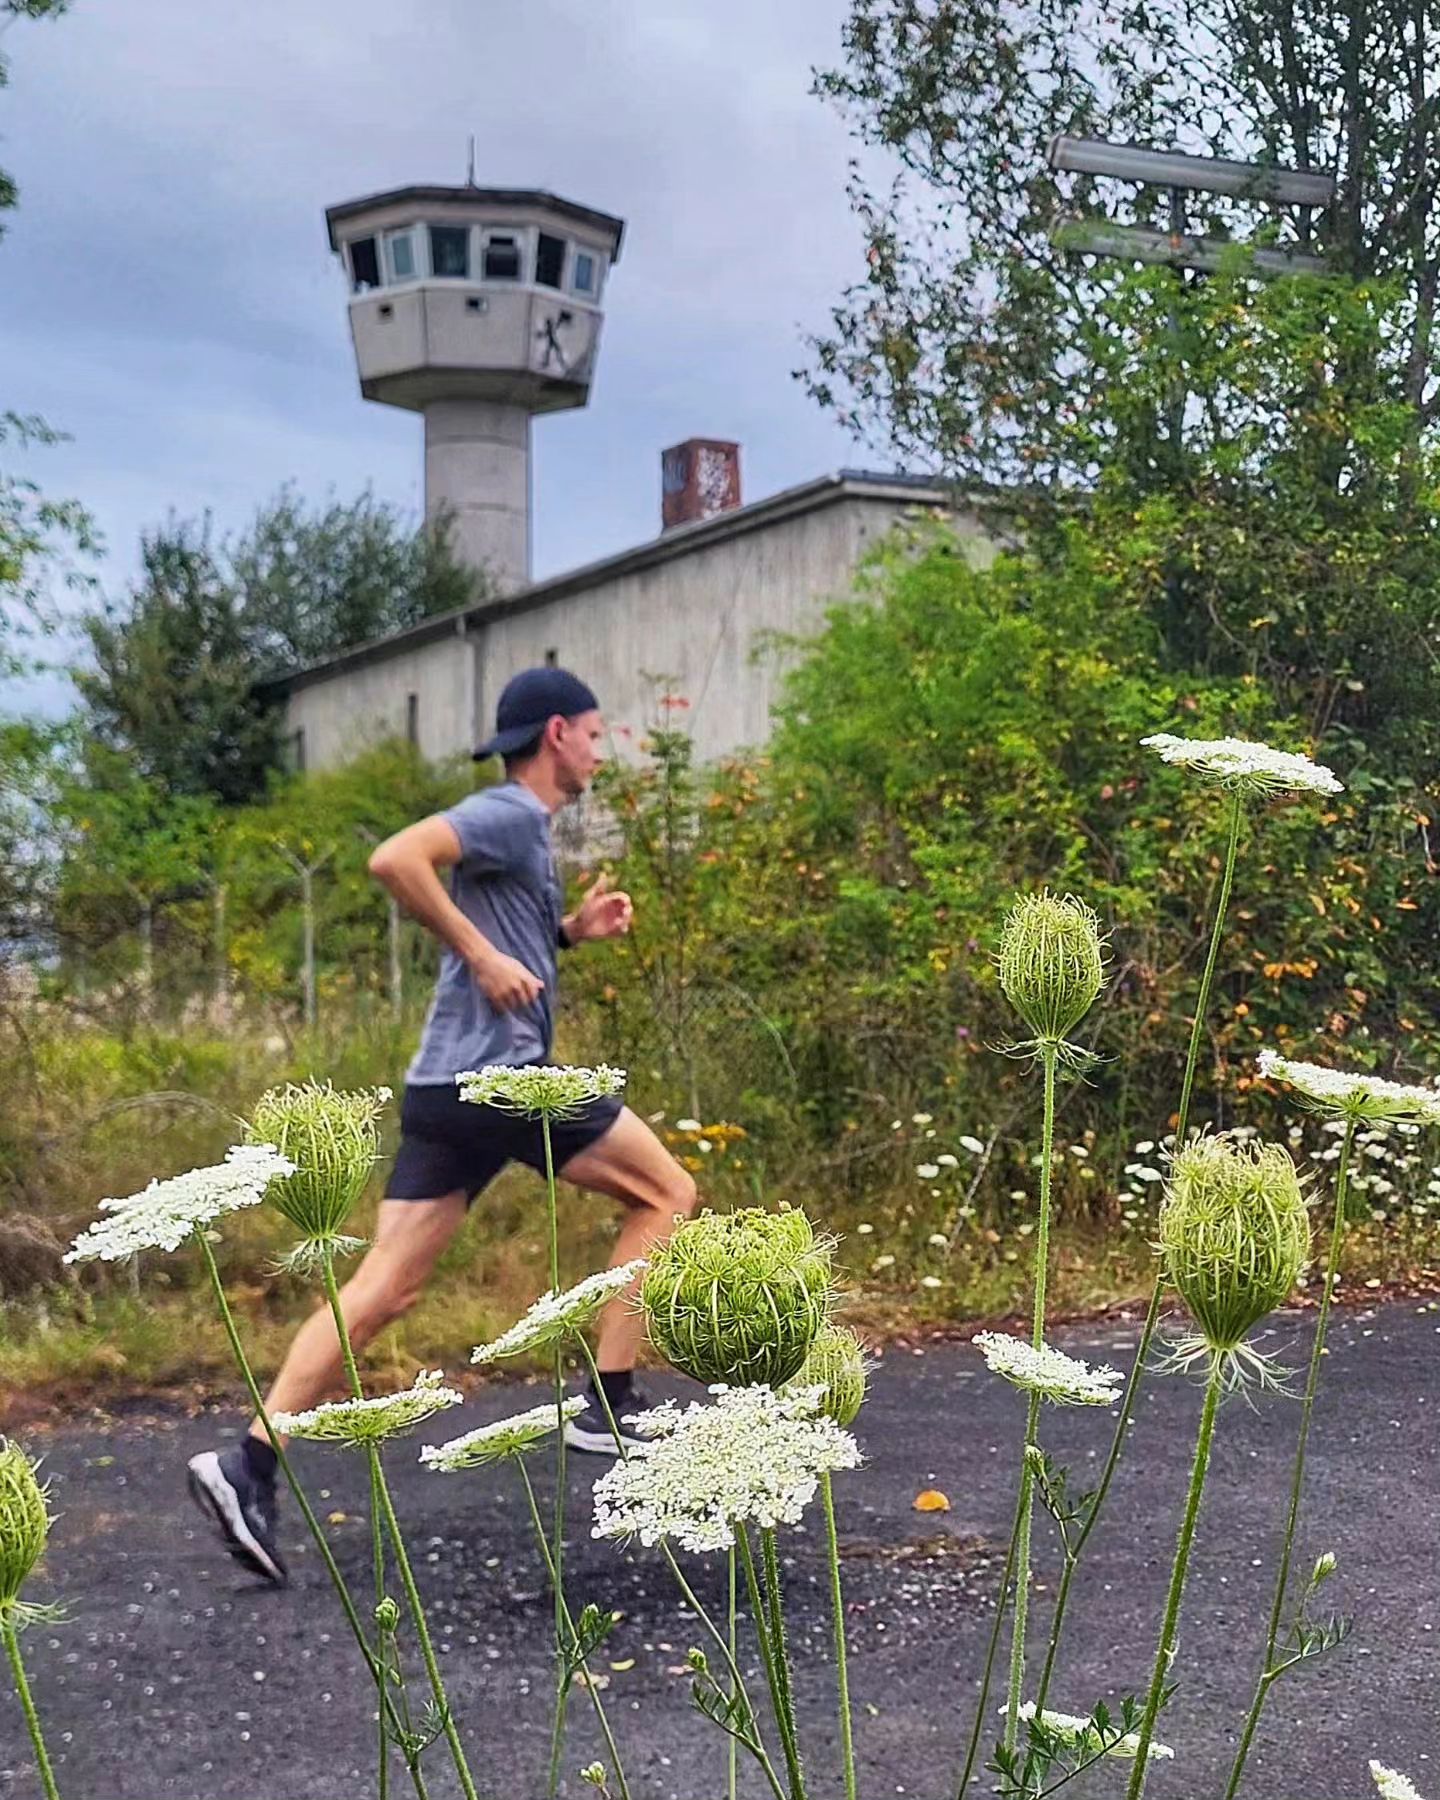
left=248, top=1082, right=391, bottom=1244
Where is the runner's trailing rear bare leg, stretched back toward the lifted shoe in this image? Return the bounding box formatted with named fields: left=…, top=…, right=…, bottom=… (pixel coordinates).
left=250, top=1192, right=464, bottom=1438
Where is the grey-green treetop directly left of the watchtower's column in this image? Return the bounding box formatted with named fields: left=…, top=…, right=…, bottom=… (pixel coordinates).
left=227, top=488, right=479, bottom=666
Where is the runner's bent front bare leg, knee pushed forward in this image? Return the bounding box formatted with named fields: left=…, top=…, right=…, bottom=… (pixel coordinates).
left=562, top=1107, right=697, bottom=1375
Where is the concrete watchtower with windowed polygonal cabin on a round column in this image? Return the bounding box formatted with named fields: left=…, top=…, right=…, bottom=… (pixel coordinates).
left=326, top=184, right=625, bottom=592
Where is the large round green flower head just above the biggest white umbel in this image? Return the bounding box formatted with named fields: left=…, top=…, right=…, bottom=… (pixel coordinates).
left=641, top=1206, right=833, bottom=1388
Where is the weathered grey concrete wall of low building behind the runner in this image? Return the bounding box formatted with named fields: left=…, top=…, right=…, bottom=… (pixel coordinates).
left=279, top=490, right=986, bottom=769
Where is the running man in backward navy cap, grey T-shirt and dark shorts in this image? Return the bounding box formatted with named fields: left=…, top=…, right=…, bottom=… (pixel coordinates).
left=189, top=668, right=695, bottom=1584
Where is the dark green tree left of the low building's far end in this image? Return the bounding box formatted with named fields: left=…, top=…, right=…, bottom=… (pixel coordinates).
left=74, top=520, right=279, bottom=803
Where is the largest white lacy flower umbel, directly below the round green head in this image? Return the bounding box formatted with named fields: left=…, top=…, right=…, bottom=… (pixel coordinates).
left=594, top=1386, right=860, bottom=1552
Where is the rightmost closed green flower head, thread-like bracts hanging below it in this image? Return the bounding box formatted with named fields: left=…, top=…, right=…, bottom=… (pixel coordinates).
left=1159, top=1134, right=1310, bottom=1350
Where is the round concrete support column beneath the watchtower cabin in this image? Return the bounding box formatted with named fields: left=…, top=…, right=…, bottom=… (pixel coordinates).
left=425, top=400, right=531, bottom=594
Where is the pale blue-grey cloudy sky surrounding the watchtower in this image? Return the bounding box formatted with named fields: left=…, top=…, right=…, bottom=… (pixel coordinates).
left=0, top=0, right=875, bottom=709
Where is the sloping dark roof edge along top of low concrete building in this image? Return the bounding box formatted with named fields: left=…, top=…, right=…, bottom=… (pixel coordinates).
left=257, top=468, right=956, bottom=697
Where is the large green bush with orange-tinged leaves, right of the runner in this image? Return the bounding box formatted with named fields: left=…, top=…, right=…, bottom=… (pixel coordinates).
left=572, top=509, right=1440, bottom=1193
